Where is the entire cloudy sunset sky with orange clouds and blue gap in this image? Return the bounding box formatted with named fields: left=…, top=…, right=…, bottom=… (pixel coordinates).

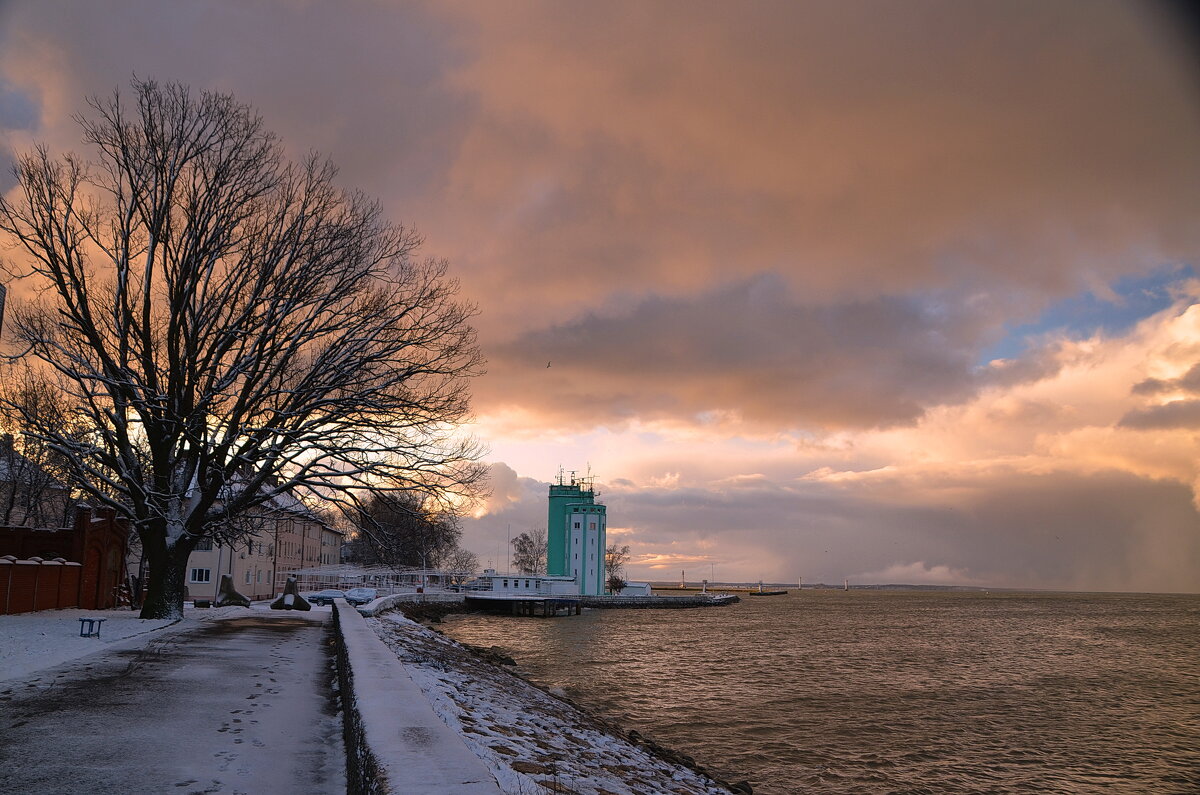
left=0, top=0, right=1200, bottom=592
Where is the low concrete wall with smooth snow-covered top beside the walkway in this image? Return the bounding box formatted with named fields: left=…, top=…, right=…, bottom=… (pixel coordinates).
left=334, top=597, right=500, bottom=795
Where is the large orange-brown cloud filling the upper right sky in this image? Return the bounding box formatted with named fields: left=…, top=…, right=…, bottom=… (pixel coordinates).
left=429, top=2, right=1200, bottom=327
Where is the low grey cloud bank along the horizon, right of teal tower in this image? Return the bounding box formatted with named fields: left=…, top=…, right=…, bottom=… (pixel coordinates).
left=465, top=470, right=1200, bottom=592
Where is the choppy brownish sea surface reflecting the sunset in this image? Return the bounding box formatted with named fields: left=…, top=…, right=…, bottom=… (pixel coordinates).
left=444, top=590, right=1200, bottom=794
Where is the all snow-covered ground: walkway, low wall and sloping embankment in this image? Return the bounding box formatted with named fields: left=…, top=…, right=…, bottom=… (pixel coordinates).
left=0, top=604, right=731, bottom=795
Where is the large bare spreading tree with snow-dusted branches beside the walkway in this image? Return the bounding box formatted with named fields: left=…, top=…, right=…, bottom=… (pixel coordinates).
left=0, top=80, right=481, bottom=617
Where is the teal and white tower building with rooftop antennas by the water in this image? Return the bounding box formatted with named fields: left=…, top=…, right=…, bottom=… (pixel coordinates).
left=546, top=472, right=606, bottom=596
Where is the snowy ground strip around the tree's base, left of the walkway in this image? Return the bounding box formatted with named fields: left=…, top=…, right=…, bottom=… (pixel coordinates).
left=0, top=602, right=328, bottom=681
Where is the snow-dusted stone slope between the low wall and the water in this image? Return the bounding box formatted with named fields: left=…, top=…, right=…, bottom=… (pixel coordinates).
left=368, top=614, right=730, bottom=795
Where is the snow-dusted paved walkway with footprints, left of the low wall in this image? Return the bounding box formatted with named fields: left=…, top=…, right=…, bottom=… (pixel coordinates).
left=0, top=611, right=346, bottom=795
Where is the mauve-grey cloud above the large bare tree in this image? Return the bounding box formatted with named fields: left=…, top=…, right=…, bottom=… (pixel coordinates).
left=0, top=0, right=469, bottom=205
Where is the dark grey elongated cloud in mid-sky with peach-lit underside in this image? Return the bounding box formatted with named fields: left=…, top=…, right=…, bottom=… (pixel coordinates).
left=484, top=276, right=1049, bottom=428
